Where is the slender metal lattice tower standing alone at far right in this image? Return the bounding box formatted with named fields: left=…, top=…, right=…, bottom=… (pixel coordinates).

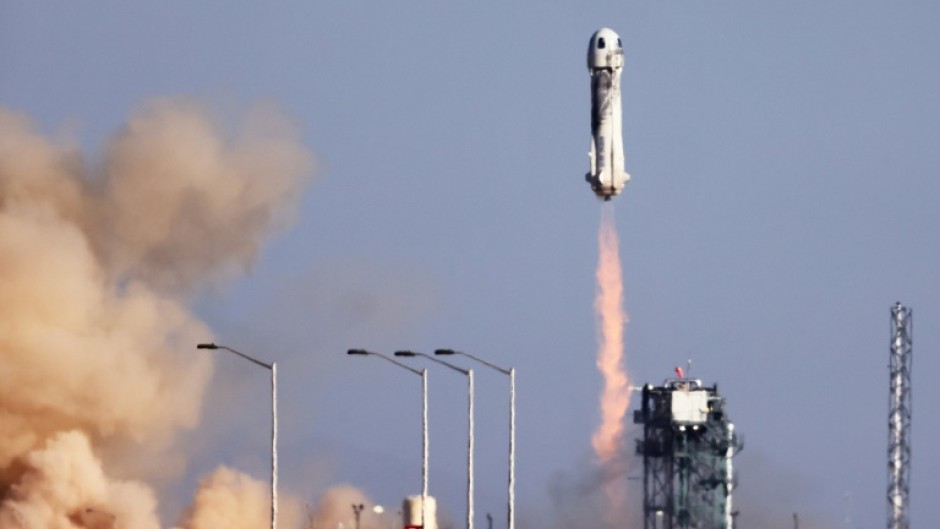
left=888, top=301, right=914, bottom=529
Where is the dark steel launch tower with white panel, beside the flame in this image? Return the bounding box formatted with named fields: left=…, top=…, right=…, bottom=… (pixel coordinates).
left=633, top=379, right=741, bottom=529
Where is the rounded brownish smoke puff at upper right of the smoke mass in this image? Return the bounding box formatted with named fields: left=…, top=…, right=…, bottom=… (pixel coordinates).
left=98, top=100, right=311, bottom=290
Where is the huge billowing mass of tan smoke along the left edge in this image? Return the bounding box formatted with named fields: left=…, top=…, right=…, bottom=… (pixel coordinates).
left=0, top=99, right=312, bottom=529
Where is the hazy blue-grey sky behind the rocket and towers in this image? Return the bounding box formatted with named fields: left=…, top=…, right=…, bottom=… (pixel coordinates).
left=0, top=0, right=940, bottom=528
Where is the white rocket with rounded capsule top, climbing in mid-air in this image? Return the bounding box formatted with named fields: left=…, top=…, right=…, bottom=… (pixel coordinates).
left=585, top=28, right=630, bottom=200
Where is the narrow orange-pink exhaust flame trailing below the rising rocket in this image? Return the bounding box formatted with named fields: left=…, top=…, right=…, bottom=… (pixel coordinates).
left=591, top=205, right=630, bottom=521
